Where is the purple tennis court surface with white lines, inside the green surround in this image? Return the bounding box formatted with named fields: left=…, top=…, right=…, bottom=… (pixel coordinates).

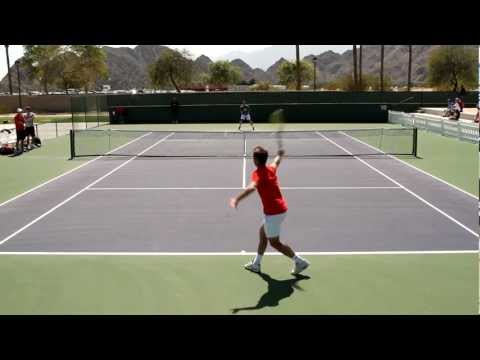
left=0, top=125, right=478, bottom=312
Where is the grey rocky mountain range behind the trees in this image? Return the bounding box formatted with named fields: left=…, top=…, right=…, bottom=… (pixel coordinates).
left=0, top=45, right=474, bottom=92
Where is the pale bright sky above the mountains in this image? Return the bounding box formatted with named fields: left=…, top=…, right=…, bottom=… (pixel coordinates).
left=0, top=45, right=352, bottom=79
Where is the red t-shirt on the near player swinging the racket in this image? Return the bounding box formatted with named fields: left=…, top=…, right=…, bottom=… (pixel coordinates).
left=252, top=165, right=288, bottom=215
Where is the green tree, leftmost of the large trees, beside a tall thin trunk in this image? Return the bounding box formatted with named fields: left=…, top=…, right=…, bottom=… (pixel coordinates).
left=22, top=45, right=62, bottom=94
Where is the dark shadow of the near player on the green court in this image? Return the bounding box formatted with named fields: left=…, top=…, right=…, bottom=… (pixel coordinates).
left=231, top=273, right=310, bottom=314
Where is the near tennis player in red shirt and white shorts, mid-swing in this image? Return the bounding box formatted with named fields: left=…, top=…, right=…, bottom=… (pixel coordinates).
left=230, top=146, right=310, bottom=274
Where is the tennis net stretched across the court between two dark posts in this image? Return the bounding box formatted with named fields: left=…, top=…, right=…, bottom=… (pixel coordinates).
left=70, top=128, right=417, bottom=158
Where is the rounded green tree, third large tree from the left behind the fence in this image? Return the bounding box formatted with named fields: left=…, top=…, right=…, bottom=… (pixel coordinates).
left=148, top=49, right=193, bottom=92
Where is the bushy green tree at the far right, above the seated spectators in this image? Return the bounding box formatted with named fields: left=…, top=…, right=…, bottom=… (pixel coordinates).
left=428, top=45, right=478, bottom=92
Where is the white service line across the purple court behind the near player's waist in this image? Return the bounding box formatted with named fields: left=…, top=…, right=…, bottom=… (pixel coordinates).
left=87, top=186, right=402, bottom=191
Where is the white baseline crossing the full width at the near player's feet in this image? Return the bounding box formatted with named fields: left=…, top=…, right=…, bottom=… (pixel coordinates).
left=0, top=250, right=478, bottom=256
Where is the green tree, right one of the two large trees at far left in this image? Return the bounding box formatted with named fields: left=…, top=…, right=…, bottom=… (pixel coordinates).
left=71, top=45, right=108, bottom=91
